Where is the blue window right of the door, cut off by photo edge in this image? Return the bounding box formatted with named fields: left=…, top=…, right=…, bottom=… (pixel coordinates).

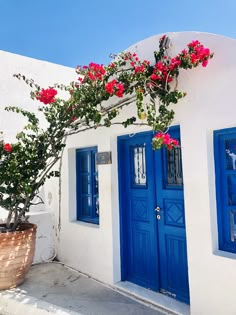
left=214, top=128, right=236, bottom=253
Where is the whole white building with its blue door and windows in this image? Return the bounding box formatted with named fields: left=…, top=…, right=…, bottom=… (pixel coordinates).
left=0, top=32, right=236, bottom=315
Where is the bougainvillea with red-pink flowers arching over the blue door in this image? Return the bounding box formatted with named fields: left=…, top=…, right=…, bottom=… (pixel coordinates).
left=0, top=36, right=213, bottom=231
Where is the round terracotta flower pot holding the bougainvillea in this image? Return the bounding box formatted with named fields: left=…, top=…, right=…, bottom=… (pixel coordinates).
left=0, top=223, right=37, bottom=290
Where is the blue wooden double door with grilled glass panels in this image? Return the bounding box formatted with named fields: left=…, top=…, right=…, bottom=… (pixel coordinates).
left=118, top=127, right=189, bottom=303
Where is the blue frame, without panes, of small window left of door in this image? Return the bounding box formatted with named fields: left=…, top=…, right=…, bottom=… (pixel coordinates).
left=75, top=146, right=99, bottom=224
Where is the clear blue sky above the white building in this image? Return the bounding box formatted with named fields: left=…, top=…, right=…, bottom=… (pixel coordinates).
left=0, top=0, right=236, bottom=67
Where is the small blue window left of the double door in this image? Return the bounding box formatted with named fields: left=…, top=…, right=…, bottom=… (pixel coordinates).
left=76, top=147, right=99, bottom=224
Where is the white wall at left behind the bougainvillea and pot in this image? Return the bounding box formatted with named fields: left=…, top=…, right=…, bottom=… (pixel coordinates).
left=0, top=51, right=76, bottom=262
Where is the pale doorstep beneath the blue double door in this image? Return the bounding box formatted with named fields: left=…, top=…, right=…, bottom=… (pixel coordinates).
left=115, top=281, right=190, bottom=315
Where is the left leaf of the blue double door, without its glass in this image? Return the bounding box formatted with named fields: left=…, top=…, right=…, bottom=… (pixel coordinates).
left=118, top=134, right=158, bottom=290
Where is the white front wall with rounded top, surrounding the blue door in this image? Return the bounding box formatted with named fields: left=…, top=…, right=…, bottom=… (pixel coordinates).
left=54, top=32, right=236, bottom=315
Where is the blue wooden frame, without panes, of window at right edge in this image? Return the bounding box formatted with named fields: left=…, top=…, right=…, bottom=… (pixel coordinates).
left=214, top=127, right=236, bottom=253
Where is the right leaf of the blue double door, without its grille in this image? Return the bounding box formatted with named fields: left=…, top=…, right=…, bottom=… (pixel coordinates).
left=155, top=127, right=189, bottom=303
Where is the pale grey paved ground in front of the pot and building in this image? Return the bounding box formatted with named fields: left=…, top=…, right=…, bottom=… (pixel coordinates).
left=0, top=263, right=173, bottom=315
